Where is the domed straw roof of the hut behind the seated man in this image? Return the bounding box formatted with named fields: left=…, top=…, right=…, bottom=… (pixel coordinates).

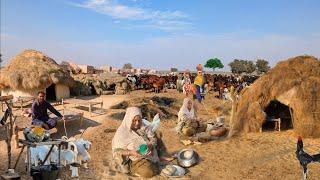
left=0, top=50, right=74, bottom=91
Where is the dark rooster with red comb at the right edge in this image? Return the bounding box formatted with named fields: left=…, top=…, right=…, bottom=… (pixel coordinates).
left=296, top=136, right=320, bottom=180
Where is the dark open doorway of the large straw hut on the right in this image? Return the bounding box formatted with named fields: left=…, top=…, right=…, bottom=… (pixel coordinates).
left=262, top=100, right=293, bottom=131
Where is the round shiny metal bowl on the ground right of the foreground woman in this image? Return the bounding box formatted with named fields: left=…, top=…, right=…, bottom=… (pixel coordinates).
left=178, top=149, right=199, bottom=167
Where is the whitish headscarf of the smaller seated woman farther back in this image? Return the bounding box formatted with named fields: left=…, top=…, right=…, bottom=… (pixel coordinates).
left=176, top=98, right=196, bottom=133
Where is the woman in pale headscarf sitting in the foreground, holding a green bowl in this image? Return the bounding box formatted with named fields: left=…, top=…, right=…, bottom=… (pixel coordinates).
left=112, top=107, right=171, bottom=178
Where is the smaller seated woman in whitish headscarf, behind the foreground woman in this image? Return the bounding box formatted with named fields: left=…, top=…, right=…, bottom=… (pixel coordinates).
left=176, top=98, right=207, bottom=137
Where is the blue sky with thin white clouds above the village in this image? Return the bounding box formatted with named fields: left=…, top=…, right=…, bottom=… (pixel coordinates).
left=0, top=0, right=320, bottom=71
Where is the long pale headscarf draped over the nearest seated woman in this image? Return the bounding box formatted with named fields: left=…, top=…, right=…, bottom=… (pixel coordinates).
left=112, top=107, right=146, bottom=156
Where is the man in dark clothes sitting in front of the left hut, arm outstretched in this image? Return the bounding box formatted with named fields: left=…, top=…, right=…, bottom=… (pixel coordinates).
left=31, top=91, right=63, bottom=130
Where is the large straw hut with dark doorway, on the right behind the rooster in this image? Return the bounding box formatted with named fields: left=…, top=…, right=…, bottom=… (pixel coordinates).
left=229, top=56, right=320, bottom=137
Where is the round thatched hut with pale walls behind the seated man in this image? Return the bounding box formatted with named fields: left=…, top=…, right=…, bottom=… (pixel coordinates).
left=0, top=50, right=74, bottom=100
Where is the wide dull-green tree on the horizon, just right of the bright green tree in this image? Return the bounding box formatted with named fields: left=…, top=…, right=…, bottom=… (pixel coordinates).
left=229, top=59, right=256, bottom=74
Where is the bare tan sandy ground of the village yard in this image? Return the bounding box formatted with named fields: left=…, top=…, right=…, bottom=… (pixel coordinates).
left=0, top=90, right=320, bottom=180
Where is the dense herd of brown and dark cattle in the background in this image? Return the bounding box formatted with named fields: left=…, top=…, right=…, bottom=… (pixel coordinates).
left=126, top=74, right=259, bottom=98
